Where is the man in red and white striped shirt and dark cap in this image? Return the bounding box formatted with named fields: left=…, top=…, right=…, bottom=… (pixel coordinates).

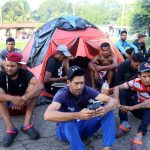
left=114, top=63, right=150, bottom=150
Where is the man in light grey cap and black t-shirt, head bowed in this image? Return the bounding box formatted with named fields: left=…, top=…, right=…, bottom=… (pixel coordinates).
left=44, top=45, right=71, bottom=95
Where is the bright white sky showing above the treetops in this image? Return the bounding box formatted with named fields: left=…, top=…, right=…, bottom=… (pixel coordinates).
left=0, top=0, right=135, bottom=11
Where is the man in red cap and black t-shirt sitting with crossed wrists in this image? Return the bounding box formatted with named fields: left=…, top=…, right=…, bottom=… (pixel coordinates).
left=0, top=52, right=43, bottom=147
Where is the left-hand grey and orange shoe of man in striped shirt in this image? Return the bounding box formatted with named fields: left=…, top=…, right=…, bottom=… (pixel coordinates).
left=116, top=123, right=131, bottom=138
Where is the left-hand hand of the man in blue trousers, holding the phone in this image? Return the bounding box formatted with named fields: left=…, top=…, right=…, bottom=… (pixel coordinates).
left=78, top=108, right=96, bottom=120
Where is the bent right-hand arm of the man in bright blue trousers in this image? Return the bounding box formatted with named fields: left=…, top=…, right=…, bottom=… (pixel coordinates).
left=95, top=94, right=117, bottom=113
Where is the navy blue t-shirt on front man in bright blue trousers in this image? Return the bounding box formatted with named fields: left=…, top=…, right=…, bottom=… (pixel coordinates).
left=53, top=86, right=99, bottom=112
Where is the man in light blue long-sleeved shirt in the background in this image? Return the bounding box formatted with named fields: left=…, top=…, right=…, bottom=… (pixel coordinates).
left=115, top=31, right=138, bottom=59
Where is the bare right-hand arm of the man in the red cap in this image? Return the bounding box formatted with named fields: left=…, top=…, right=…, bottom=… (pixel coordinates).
left=22, top=77, right=44, bottom=100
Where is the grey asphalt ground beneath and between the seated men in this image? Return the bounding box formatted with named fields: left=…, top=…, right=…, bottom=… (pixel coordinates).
left=0, top=105, right=150, bottom=150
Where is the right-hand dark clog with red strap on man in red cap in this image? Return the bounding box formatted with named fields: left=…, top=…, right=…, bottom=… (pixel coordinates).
left=21, top=125, right=40, bottom=140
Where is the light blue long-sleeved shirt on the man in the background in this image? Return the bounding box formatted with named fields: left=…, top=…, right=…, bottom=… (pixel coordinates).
left=115, top=39, right=138, bottom=54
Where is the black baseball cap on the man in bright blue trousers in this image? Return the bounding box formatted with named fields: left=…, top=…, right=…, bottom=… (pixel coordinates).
left=67, top=66, right=85, bottom=80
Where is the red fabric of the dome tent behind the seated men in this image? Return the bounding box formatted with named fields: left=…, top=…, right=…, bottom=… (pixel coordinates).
left=24, top=18, right=124, bottom=81
